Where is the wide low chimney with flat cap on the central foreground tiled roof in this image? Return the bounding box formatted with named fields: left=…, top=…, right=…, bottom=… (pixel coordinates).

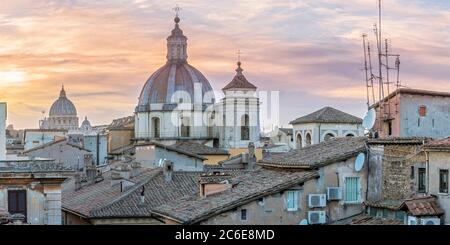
left=199, top=172, right=232, bottom=197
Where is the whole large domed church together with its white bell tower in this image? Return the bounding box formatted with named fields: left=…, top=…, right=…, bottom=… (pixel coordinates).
left=135, top=16, right=260, bottom=148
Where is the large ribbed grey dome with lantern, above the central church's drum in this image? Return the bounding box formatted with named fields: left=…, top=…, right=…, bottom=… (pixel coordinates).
left=136, top=17, right=214, bottom=111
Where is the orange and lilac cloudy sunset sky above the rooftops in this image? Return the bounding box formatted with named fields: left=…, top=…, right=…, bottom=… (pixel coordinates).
left=0, top=0, right=450, bottom=128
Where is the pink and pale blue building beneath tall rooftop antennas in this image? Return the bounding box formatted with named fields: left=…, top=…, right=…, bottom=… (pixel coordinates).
left=371, top=88, right=450, bottom=139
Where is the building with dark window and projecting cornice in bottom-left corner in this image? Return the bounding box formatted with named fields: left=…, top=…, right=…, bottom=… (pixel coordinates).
left=0, top=160, right=71, bottom=225
